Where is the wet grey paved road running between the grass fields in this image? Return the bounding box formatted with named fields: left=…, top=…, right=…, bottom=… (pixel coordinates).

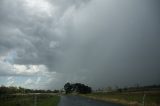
left=58, top=96, right=122, bottom=106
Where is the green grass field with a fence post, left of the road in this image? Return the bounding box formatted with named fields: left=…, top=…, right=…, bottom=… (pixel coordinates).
left=0, top=94, right=60, bottom=106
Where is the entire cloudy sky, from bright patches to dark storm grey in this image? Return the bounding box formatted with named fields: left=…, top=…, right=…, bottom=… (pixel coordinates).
left=0, top=0, right=160, bottom=90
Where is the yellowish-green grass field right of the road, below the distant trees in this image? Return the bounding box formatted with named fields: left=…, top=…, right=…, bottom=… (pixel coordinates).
left=83, top=92, right=160, bottom=106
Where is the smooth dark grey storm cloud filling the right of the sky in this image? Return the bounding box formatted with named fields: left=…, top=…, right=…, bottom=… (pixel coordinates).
left=56, top=0, right=160, bottom=86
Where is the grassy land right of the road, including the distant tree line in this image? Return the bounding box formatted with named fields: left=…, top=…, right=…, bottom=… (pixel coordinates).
left=83, top=86, right=160, bottom=106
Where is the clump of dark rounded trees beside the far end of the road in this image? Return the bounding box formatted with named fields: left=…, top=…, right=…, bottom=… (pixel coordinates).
left=64, top=82, right=92, bottom=94
